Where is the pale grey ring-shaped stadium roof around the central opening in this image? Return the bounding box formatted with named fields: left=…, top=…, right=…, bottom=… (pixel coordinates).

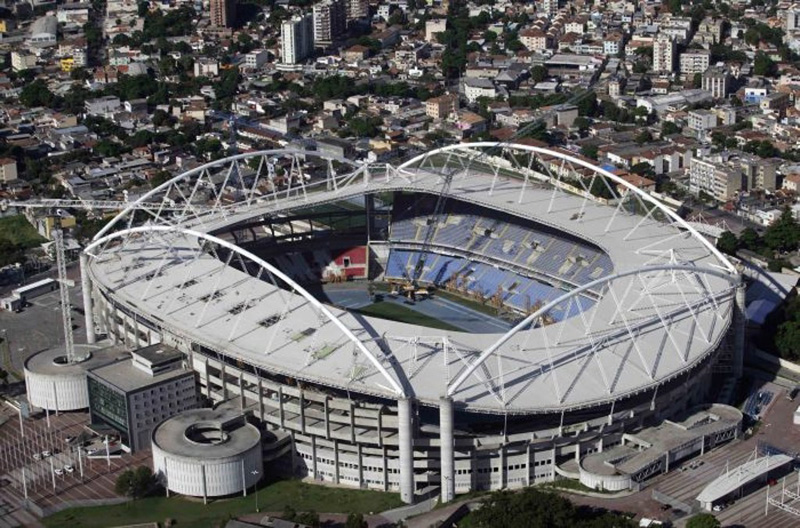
left=87, top=147, right=733, bottom=413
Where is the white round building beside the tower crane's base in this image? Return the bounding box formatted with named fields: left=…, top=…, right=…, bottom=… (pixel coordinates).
left=25, top=345, right=123, bottom=411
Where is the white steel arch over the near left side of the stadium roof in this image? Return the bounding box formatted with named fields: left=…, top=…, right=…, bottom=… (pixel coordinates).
left=83, top=225, right=408, bottom=398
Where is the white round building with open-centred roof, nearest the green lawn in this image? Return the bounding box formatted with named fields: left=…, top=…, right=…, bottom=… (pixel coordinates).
left=152, top=409, right=264, bottom=499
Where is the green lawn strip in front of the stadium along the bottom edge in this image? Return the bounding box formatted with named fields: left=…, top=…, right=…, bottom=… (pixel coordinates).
left=42, top=480, right=402, bottom=528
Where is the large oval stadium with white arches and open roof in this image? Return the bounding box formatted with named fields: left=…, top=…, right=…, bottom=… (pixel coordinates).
left=82, top=143, right=743, bottom=503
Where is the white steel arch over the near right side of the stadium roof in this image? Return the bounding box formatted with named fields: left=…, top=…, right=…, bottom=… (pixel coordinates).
left=446, top=264, right=739, bottom=397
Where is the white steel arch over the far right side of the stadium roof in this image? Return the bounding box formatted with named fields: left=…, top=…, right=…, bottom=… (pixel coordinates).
left=397, top=141, right=737, bottom=274
